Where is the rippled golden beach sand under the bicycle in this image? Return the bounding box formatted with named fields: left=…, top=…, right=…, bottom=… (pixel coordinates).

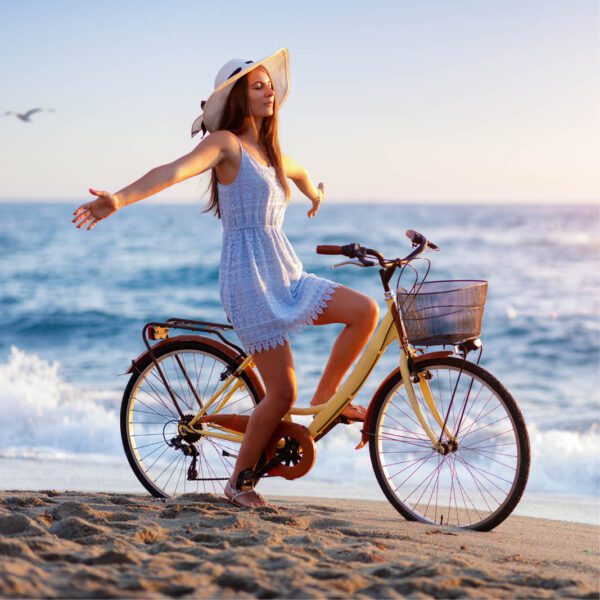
left=0, top=491, right=600, bottom=598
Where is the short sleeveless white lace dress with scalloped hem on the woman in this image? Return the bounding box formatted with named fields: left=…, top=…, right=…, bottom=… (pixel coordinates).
left=218, top=134, right=339, bottom=354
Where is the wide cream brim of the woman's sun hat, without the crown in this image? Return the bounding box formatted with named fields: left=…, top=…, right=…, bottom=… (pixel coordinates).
left=192, top=48, right=290, bottom=137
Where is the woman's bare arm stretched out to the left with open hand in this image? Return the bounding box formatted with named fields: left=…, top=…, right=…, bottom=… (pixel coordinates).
left=73, top=131, right=231, bottom=231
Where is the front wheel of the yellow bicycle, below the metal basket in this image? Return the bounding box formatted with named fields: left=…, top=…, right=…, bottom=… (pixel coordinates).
left=369, top=357, right=530, bottom=531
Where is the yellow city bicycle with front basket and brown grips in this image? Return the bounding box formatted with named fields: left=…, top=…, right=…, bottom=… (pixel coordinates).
left=121, top=230, right=530, bottom=531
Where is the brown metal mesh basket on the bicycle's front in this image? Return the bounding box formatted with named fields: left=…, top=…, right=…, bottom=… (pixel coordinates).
left=397, top=280, right=487, bottom=346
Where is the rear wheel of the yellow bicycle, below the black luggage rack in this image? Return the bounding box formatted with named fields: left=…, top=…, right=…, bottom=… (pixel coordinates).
left=121, top=337, right=261, bottom=498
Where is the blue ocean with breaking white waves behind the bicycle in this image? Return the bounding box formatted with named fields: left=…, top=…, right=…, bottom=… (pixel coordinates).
left=0, top=201, right=600, bottom=523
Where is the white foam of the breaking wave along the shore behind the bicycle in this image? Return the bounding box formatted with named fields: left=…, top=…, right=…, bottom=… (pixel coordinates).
left=0, top=347, right=600, bottom=496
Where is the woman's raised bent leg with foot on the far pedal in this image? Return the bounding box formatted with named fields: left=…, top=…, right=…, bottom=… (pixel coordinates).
left=311, top=286, right=379, bottom=417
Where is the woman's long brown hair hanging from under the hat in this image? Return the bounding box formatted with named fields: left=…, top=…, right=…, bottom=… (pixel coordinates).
left=203, top=67, right=291, bottom=219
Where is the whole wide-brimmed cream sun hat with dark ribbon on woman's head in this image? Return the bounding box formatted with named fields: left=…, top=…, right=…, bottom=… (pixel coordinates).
left=192, top=48, right=290, bottom=137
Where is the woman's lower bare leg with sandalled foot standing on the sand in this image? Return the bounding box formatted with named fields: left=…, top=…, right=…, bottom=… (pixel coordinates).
left=230, top=342, right=296, bottom=506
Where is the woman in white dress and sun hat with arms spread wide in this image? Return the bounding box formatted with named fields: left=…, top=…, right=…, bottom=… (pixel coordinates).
left=73, top=48, right=378, bottom=506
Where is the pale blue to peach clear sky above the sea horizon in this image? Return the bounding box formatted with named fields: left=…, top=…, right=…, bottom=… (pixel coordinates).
left=0, top=0, right=600, bottom=203
